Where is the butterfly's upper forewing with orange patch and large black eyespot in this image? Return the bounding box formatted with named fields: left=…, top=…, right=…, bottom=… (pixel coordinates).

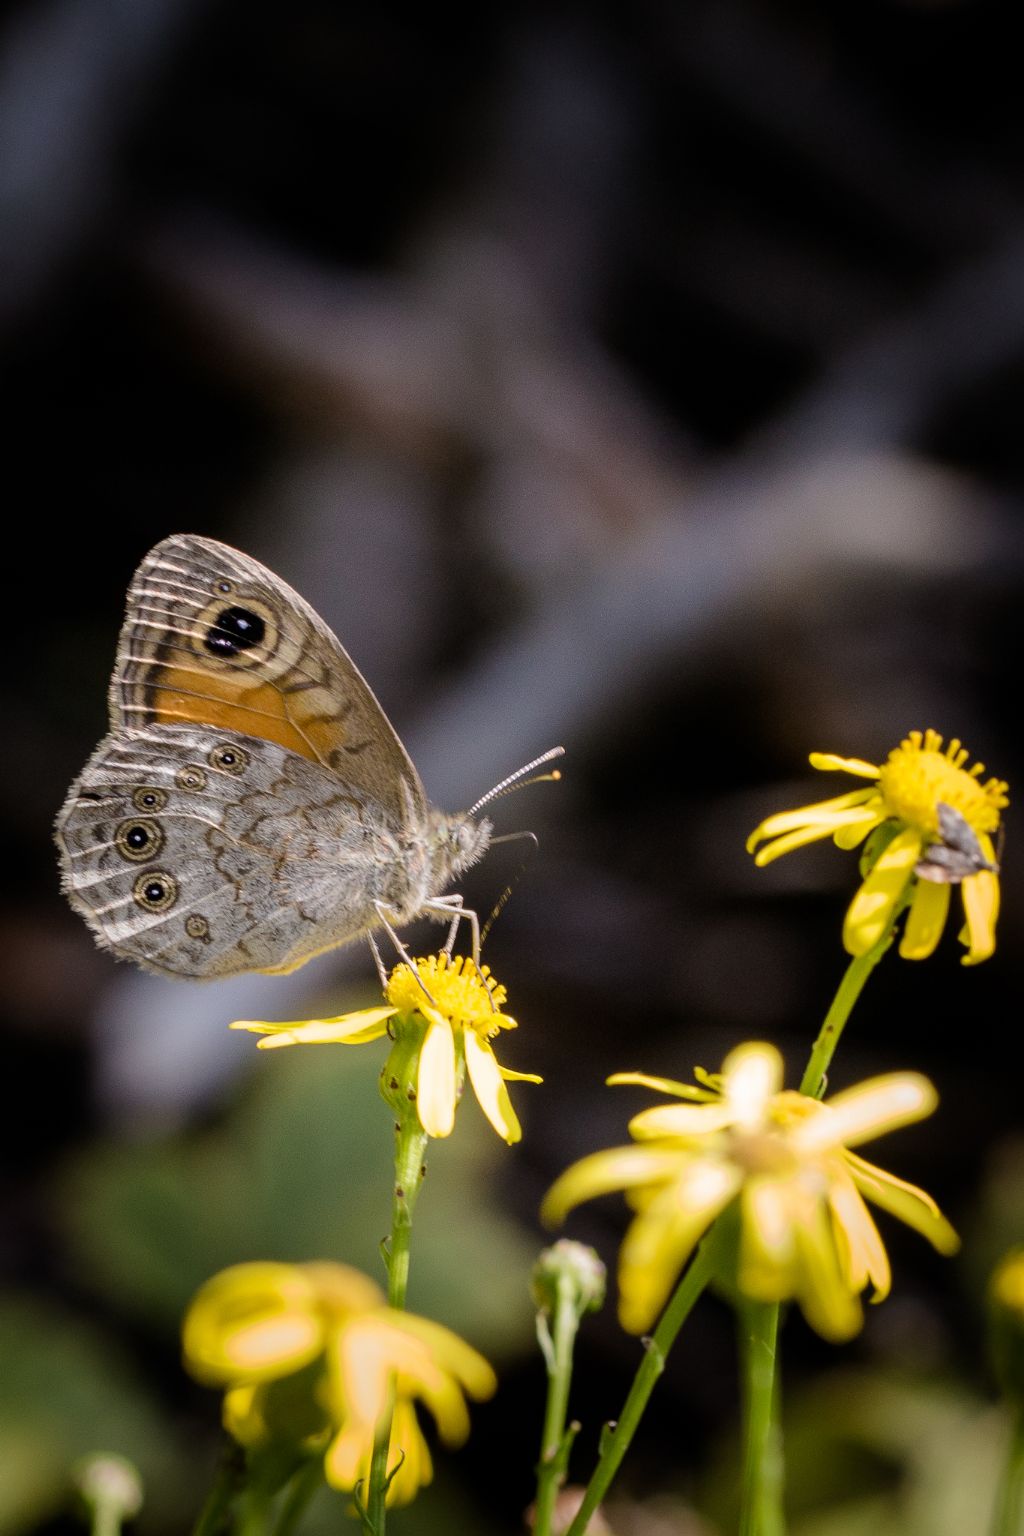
left=109, top=533, right=427, bottom=822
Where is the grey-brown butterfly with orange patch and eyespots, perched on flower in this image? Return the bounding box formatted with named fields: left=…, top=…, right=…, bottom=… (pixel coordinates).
left=55, top=533, right=560, bottom=978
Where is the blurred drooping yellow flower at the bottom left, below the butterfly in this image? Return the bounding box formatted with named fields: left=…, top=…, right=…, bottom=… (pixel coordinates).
left=183, top=1263, right=497, bottom=1504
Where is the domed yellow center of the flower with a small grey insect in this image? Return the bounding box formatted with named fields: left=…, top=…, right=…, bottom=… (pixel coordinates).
left=878, top=731, right=1009, bottom=837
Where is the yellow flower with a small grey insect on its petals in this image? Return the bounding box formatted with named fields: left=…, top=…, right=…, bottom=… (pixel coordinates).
left=746, top=731, right=1009, bottom=965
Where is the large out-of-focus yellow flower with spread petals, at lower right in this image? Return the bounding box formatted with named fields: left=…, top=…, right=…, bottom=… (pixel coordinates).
left=542, top=1043, right=958, bottom=1339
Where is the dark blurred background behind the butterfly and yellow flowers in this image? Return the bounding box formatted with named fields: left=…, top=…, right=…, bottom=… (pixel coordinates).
left=0, top=0, right=1024, bottom=1536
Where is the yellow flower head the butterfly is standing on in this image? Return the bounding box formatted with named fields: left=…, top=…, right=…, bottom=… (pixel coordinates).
left=232, top=951, right=542, bottom=1146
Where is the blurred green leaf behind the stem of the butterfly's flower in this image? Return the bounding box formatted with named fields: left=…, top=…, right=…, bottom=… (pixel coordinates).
left=61, top=1046, right=534, bottom=1355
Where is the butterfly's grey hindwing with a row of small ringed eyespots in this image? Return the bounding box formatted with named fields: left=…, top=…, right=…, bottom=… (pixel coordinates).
left=57, top=723, right=425, bottom=978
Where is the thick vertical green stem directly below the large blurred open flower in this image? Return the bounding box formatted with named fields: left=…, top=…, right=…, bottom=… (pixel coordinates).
left=738, top=1301, right=786, bottom=1536
